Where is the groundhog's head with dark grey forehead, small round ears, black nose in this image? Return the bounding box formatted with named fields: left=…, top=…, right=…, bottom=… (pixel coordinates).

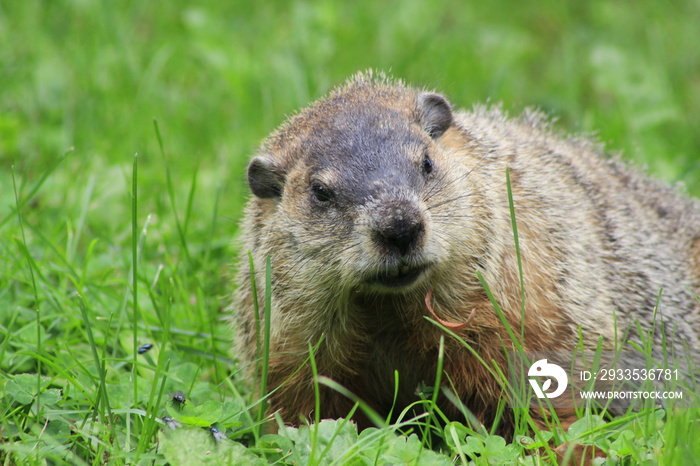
left=248, top=74, right=464, bottom=292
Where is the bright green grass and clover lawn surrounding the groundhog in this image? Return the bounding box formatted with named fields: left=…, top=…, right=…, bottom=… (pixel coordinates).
left=0, top=0, right=700, bottom=464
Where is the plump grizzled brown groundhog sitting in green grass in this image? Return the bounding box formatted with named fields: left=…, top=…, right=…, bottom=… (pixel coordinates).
left=232, top=72, right=700, bottom=431
